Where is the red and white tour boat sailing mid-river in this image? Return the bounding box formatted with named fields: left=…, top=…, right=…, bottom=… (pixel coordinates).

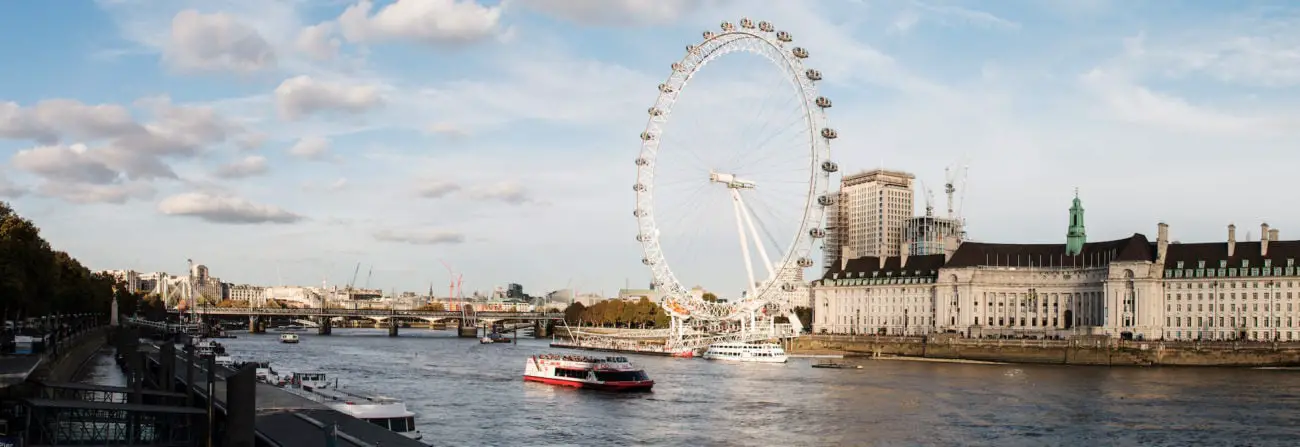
left=524, top=353, right=654, bottom=391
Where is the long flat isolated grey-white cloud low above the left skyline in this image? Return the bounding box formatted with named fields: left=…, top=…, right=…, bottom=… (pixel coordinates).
left=157, top=192, right=303, bottom=224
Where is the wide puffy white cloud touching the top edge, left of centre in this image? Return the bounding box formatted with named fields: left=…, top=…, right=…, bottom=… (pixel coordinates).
left=338, top=0, right=502, bottom=45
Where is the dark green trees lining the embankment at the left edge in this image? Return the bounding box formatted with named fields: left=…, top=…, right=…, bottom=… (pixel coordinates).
left=0, top=201, right=133, bottom=318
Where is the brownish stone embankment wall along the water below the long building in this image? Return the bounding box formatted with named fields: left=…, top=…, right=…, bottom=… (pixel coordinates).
left=785, top=335, right=1300, bottom=366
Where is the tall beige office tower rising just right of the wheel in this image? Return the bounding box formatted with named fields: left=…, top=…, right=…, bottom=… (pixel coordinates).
left=824, top=169, right=917, bottom=268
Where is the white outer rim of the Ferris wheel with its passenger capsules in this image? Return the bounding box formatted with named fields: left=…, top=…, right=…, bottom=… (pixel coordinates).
left=633, top=19, right=835, bottom=320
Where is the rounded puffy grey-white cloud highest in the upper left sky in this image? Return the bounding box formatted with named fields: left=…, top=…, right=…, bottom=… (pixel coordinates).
left=163, top=9, right=276, bottom=73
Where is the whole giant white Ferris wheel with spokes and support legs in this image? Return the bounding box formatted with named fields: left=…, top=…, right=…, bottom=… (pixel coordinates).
left=632, top=18, right=839, bottom=322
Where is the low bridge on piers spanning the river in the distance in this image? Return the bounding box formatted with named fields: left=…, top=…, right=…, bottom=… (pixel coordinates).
left=144, top=305, right=564, bottom=338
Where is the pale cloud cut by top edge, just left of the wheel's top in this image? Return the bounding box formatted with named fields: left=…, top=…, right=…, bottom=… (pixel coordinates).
left=519, top=0, right=705, bottom=26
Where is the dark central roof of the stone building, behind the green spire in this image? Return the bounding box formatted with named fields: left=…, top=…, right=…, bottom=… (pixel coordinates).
left=944, top=233, right=1156, bottom=268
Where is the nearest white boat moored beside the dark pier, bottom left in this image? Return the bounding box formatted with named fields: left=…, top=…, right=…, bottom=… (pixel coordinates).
left=285, top=373, right=424, bottom=439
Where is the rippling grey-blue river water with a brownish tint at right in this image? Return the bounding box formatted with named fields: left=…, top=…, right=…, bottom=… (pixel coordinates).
left=90, top=329, right=1300, bottom=446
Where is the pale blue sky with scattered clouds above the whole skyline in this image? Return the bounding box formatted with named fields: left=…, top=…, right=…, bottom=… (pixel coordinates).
left=0, top=0, right=1300, bottom=300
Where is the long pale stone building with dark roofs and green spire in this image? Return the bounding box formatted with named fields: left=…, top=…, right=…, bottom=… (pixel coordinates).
left=813, top=193, right=1300, bottom=340
